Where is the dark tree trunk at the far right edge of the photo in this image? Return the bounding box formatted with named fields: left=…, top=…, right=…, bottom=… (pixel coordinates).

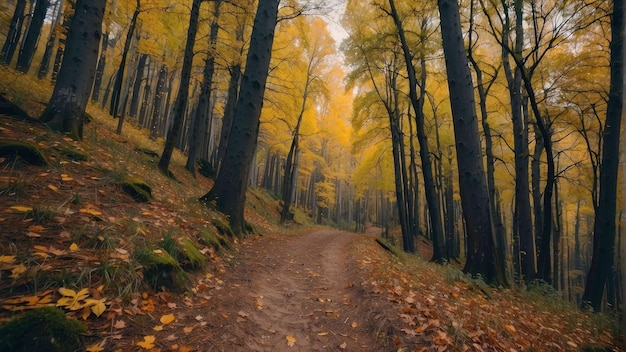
left=583, top=0, right=624, bottom=312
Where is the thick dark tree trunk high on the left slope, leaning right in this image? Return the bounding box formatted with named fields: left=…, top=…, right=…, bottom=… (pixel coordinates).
left=41, top=0, right=106, bottom=139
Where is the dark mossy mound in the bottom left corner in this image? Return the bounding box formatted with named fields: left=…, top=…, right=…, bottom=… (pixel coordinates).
left=0, top=307, right=87, bottom=352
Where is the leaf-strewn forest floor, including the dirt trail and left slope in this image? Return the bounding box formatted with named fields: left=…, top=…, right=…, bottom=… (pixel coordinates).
left=0, top=71, right=619, bottom=352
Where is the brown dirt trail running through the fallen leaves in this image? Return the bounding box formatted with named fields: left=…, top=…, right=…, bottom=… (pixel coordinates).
left=195, top=229, right=387, bottom=351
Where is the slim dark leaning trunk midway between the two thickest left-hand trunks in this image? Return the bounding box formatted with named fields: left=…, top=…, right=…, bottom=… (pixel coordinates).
left=159, top=0, right=202, bottom=175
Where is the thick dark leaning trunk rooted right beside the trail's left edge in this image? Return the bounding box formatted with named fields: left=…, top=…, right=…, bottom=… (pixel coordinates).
left=201, top=0, right=279, bottom=235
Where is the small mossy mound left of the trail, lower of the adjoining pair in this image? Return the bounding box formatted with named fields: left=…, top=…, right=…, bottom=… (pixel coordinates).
left=136, top=248, right=189, bottom=293
